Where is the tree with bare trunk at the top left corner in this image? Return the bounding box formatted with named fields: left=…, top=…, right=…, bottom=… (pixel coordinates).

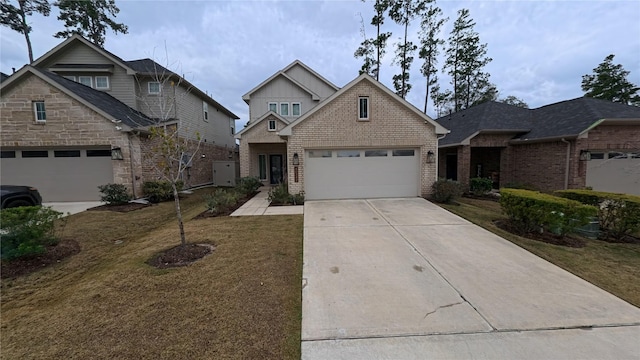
left=0, top=0, right=51, bottom=63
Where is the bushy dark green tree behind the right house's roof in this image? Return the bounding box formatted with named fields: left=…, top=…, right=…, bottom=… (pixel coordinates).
left=582, top=54, right=640, bottom=106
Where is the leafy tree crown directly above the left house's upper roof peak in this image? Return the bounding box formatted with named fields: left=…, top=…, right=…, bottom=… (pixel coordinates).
left=54, top=0, right=128, bottom=47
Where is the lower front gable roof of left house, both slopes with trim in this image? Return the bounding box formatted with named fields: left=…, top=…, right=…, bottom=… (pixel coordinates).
left=0, top=65, right=156, bottom=130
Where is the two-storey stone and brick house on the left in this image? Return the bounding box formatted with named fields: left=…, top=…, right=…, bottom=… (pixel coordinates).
left=0, top=35, right=238, bottom=202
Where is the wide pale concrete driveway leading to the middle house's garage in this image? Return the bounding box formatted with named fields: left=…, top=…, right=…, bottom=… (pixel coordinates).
left=302, top=198, right=640, bottom=359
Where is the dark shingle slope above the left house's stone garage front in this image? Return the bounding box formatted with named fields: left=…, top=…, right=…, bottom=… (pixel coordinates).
left=32, top=68, right=156, bottom=128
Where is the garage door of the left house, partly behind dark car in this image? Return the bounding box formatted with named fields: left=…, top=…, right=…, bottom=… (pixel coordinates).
left=0, top=149, right=113, bottom=202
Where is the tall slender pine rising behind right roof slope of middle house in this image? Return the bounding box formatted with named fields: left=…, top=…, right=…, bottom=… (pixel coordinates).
left=418, top=5, right=449, bottom=114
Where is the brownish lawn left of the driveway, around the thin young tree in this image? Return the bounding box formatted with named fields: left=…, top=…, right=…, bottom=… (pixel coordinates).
left=0, top=189, right=302, bottom=359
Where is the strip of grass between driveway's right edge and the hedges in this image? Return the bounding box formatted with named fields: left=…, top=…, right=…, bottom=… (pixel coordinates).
left=439, top=198, right=640, bottom=307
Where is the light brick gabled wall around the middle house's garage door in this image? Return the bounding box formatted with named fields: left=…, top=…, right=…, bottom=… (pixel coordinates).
left=287, top=80, right=437, bottom=196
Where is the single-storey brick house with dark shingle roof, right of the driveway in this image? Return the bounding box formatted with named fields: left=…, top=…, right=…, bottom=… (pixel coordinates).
left=436, top=97, right=640, bottom=194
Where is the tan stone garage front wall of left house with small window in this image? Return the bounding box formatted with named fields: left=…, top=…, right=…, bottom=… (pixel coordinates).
left=0, top=75, right=142, bottom=194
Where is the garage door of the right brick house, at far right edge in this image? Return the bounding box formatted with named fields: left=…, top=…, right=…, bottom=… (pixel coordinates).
left=587, top=150, right=640, bottom=195
